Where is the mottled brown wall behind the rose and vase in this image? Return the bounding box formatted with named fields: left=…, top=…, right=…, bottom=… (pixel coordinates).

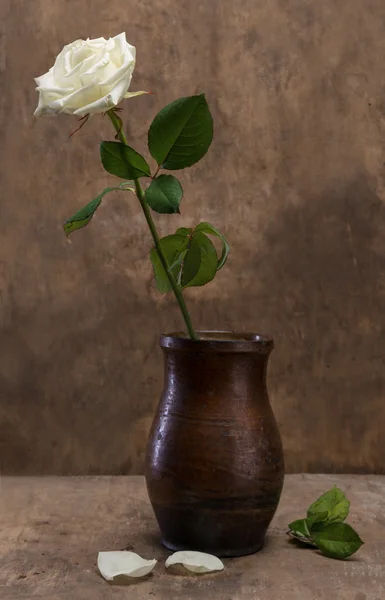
left=0, top=0, right=385, bottom=474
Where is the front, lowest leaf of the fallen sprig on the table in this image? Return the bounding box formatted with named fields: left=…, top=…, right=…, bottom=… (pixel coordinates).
left=312, top=523, right=364, bottom=558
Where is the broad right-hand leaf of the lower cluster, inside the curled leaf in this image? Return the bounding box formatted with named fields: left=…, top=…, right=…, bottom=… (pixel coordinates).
left=182, top=230, right=218, bottom=287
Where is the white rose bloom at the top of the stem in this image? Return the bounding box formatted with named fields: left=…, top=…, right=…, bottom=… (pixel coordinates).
left=34, top=33, right=146, bottom=117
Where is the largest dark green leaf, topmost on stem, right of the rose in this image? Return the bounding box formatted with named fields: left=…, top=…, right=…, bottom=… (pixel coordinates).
left=148, top=94, right=213, bottom=170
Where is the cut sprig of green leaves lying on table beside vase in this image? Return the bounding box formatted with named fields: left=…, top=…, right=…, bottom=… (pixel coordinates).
left=288, top=486, right=364, bottom=559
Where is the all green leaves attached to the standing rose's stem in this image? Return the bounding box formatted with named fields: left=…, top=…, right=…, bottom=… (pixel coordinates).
left=64, top=94, right=230, bottom=293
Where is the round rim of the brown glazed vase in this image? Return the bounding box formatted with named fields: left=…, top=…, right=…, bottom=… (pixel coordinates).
left=160, top=330, right=274, bottom=354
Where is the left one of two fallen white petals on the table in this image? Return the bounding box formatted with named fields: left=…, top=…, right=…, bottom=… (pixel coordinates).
left=98, top=550, right=157, bottom=581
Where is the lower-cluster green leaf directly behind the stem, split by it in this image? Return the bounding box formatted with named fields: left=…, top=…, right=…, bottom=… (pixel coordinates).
left=150, top=233, right=188, bottom=294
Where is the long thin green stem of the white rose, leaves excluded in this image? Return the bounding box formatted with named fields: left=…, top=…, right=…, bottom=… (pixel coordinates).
left=107, top=110, right=198, bottom=340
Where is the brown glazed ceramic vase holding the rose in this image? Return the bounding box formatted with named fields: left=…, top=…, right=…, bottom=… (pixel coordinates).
left=145, top=332, right=284, bottom=557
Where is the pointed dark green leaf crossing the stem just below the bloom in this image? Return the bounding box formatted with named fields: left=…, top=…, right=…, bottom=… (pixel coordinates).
left=100, top=142, right=150, bottom=179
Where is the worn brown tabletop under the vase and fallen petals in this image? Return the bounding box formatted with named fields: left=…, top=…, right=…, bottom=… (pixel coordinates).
left=0, top=475, right=385, bottom=600
